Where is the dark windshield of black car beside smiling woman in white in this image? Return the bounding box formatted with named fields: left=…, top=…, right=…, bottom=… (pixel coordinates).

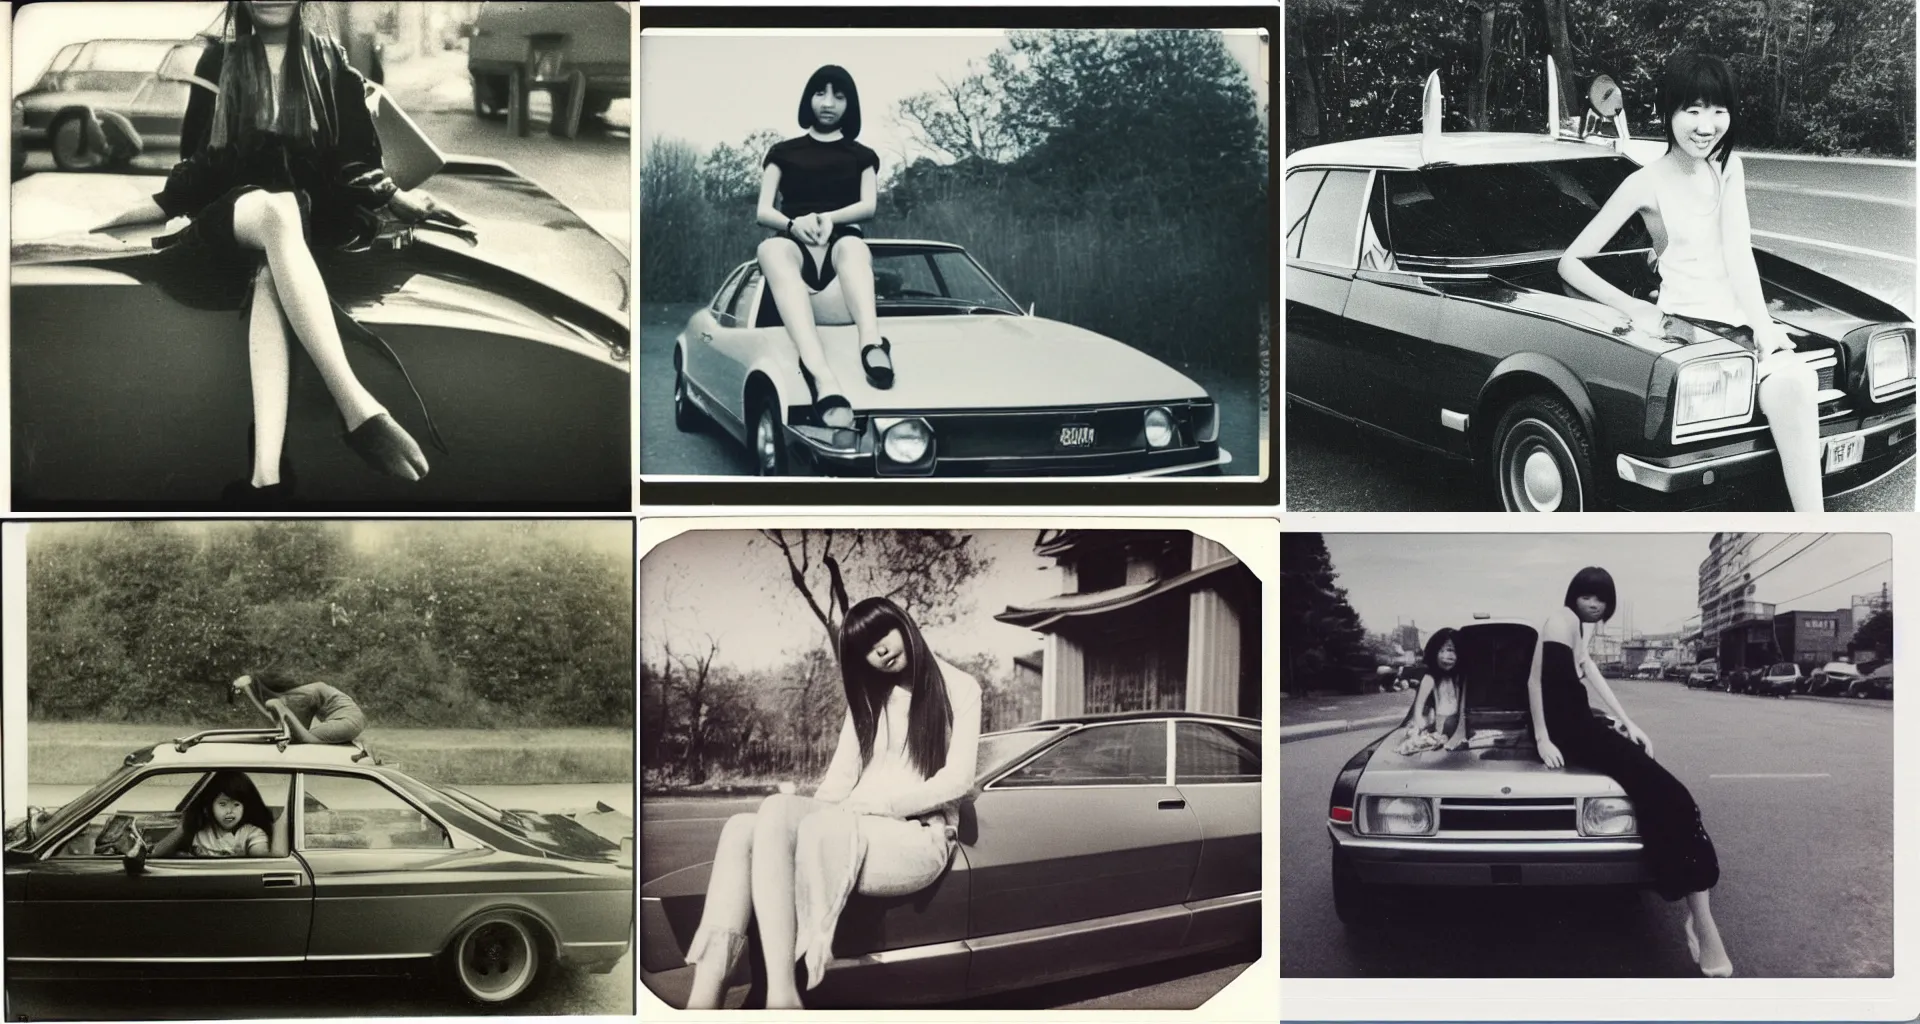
left=1384, top=156, right=1651, bottom=259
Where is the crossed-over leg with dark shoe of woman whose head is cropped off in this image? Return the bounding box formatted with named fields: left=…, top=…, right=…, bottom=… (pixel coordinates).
left=234, top=192, right=426, bottom=480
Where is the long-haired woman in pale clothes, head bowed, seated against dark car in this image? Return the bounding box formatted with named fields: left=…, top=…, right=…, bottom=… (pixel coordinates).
left=687, top=597, right=979, bottom=1009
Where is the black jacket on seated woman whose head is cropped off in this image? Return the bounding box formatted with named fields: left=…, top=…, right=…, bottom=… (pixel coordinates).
left=154, top=37, right=397, bottom=244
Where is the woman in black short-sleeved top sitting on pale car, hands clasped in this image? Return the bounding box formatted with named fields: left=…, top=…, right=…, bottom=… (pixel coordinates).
left=755, top=63, right=893, bottom=428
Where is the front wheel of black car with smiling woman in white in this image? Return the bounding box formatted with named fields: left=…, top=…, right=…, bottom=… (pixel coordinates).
left=1490, top=394, right=1599, bottom=511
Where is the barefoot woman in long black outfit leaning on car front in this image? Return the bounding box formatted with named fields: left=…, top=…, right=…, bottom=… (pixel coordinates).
left=1526, top=567, right=1734, bottom=978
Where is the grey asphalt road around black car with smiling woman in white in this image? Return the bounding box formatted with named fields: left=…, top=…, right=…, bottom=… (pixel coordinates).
left=1283, top=156, right=1914, bottom=511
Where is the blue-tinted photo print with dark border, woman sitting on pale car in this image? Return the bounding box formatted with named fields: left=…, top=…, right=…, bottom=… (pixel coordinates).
left=637, top=8, right=1277, bottom=503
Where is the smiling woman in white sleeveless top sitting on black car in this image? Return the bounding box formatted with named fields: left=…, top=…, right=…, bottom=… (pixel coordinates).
left=1559, top=54, right=1824, bottom=511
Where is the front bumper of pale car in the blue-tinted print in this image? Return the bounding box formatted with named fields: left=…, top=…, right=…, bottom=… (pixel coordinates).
left=787, top=425, right=1233, bottom=480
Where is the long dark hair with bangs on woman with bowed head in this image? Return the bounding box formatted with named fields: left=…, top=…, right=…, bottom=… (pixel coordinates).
left=839, top=597, right=954, bottom=778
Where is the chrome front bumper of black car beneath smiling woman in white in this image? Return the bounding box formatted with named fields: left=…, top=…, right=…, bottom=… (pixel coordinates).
left=1613, top=405, right=1914, bottom=511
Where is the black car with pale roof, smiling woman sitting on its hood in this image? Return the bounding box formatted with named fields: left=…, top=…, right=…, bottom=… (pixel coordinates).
left=1284, top=67, right=1914, bottom=511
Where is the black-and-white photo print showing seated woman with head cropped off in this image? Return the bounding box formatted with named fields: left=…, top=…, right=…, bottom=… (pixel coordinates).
left=8, top=0, right=634, bottom=511
